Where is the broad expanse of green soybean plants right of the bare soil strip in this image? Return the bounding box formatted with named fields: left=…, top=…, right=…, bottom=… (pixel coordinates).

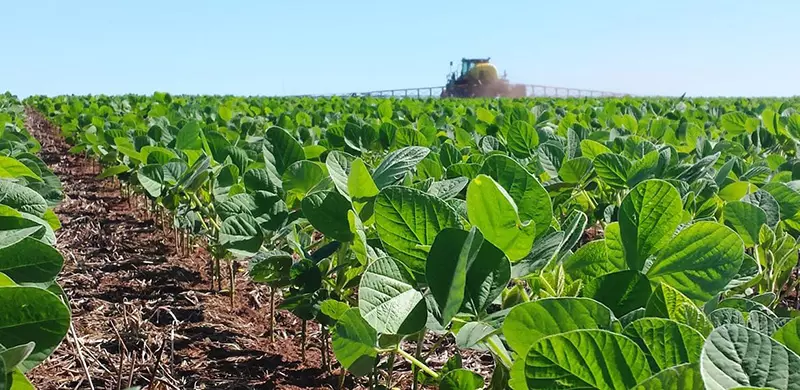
left=27, top=93, right=800, bottom=390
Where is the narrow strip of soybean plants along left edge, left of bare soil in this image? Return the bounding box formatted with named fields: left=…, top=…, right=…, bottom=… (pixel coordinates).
left=0, top=94, right=70, bottom=390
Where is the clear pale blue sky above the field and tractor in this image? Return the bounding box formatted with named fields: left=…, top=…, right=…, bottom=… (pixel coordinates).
left=0, top=0, right=800, bottom=96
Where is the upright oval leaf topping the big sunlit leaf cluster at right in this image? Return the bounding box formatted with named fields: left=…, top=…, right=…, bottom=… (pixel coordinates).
left=619, top=179, right=680, bottom=270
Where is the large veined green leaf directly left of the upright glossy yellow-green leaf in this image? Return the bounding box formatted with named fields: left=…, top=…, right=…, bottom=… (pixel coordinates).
left=375, top=186, right=461, bottom=275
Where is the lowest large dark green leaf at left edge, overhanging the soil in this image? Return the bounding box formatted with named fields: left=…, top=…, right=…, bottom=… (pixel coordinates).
left=0, top=286, right=70, bottom=371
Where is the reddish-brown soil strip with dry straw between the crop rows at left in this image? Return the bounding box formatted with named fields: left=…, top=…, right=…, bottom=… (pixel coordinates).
left=27, top=109, right=492, bottom=390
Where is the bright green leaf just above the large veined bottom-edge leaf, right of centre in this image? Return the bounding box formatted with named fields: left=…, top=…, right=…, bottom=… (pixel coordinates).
left=503, top=298, right=614, bottom=353
